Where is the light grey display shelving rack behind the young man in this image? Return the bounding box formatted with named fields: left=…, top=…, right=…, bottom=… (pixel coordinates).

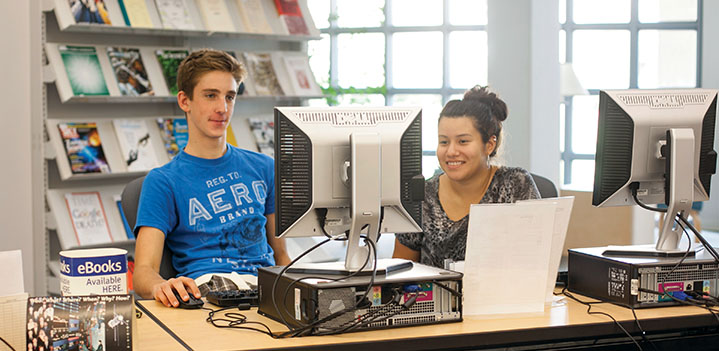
left=36, top=0, right=321, bottom=294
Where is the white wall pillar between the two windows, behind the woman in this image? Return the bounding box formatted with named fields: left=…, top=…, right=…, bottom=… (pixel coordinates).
left=487, top=0, right=560, bottom=184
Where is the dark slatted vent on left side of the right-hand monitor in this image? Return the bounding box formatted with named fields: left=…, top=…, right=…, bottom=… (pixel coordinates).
left=592, top=92, right=634, bottom=206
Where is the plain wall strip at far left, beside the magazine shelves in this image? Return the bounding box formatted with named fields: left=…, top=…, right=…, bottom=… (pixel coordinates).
left=0, top=1, right=44, bottom=293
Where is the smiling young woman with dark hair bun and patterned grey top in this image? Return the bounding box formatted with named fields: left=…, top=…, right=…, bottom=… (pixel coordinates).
left=393, top=86, right=539, bottom=267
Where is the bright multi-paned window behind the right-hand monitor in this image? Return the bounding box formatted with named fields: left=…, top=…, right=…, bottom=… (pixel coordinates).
left=559, top=0, right=701, bottom=190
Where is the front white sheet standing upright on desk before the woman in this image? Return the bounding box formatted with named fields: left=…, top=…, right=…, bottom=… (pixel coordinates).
left=462, top=201, right=557, bottom=315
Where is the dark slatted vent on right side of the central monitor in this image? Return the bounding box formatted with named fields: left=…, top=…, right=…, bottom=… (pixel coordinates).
left=399, top=113, right=422, bottom=226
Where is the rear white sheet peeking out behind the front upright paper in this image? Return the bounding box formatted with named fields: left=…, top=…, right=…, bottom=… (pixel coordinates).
left=518, top=196, right=574, bottom=303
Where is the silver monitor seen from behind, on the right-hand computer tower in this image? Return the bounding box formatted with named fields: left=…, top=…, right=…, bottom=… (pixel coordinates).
left=592, top=89, right=717, bottom=256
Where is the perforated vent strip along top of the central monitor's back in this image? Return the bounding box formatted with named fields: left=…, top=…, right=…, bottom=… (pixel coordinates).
left=295, top=110, right=411, bottom=127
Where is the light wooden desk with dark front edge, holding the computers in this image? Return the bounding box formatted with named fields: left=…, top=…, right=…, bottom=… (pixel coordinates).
left=136, top=296, right=719, bottom=351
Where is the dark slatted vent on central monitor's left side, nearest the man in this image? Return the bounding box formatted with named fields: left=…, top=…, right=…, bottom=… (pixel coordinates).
left=275, top=110, right=312, bottom=235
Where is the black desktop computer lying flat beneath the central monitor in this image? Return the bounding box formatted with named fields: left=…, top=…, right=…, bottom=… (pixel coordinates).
left=257, top=263, right=462, bottom=331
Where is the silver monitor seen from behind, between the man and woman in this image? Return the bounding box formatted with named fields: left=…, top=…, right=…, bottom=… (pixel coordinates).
left=275, top=107, right=424, bottom=272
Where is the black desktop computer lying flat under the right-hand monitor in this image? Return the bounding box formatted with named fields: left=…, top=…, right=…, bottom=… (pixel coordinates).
left=567, top=247, right=719, bottom=308
